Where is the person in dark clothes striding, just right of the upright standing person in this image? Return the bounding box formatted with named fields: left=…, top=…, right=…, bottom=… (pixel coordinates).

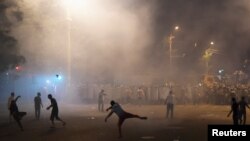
left=47, top=94, right=66, bottom=128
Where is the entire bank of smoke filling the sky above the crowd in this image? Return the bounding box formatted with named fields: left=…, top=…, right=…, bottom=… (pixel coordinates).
left=4, top=0, right=249, bottom=88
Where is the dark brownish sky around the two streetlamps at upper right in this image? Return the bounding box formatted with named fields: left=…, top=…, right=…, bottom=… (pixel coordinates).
left=146, top=0, right=250, bottom=74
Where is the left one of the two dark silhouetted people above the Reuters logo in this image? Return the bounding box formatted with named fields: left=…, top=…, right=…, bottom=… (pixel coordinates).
left=227, top=97, right=239, bottom=125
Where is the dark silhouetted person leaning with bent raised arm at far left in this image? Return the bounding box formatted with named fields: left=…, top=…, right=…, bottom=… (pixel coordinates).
left=10, top=96, right=27, bottom=131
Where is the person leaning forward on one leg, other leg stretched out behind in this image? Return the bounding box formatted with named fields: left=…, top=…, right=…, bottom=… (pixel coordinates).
left=105, top=100, right=147, bottom=138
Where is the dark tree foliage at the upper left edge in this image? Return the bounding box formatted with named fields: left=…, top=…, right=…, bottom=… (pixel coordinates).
left=0, top=0, right=25, bottom=72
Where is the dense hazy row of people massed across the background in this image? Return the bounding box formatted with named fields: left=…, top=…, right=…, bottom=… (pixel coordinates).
left=78, top=83, right=250, bottom=105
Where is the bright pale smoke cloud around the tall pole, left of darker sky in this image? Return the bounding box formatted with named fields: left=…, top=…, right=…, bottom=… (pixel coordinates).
left=11, top=0, right=156, bottom=82
